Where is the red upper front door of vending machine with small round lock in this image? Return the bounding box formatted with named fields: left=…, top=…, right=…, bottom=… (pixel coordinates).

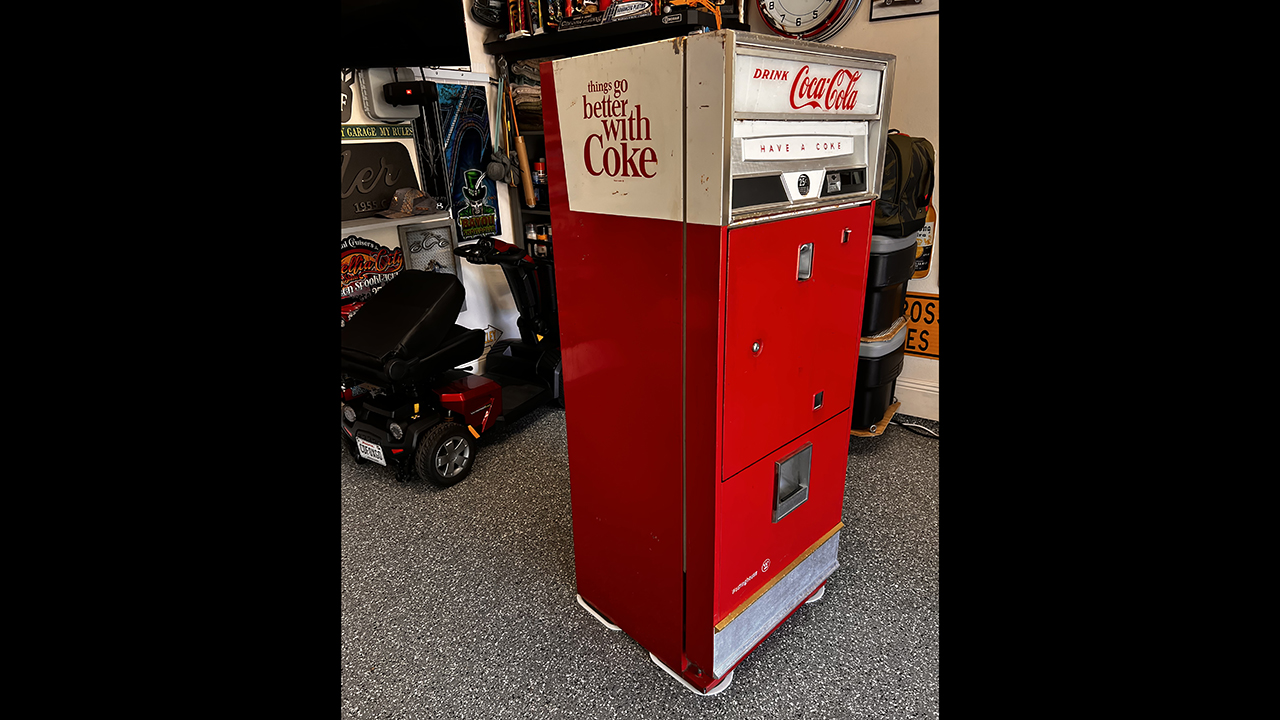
left=723, top=205, right=872, bottom=478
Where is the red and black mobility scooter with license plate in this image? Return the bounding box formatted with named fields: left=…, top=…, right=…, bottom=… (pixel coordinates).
left=342, top=238, right=563, bottom=487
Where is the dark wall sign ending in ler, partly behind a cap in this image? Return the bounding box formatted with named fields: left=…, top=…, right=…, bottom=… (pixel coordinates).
left=342, top=139, right=419, bottom=220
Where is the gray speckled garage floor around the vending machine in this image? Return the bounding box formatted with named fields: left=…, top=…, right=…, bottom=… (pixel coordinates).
left=342, top=407, right=940, bottom=720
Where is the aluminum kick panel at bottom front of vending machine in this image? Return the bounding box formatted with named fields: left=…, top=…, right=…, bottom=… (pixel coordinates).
left=712, top=532, right=840, bottom=678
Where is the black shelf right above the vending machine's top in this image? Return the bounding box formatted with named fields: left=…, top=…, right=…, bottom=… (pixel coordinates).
left=484, top=9, right=748, bottom=63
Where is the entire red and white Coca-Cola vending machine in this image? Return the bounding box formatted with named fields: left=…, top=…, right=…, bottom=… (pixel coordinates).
left=541, top=31, right=895, bottom=694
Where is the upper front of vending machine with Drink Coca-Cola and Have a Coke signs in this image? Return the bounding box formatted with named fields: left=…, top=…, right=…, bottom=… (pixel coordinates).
left=686, top=31, right=896, bottom=223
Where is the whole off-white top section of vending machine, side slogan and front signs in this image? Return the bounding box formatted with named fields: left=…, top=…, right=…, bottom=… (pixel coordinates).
left=543, top=29, right=895, bottom=225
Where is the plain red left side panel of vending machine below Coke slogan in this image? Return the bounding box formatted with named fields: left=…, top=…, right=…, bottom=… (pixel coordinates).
left=541, top=63, right=684, bottom=667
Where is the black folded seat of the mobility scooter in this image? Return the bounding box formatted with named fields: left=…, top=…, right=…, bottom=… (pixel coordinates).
left=342, top=270, right=484, bottom=382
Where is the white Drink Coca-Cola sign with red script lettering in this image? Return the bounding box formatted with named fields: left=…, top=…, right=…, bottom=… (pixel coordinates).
left=733, top=55, right=883, bottom=115
